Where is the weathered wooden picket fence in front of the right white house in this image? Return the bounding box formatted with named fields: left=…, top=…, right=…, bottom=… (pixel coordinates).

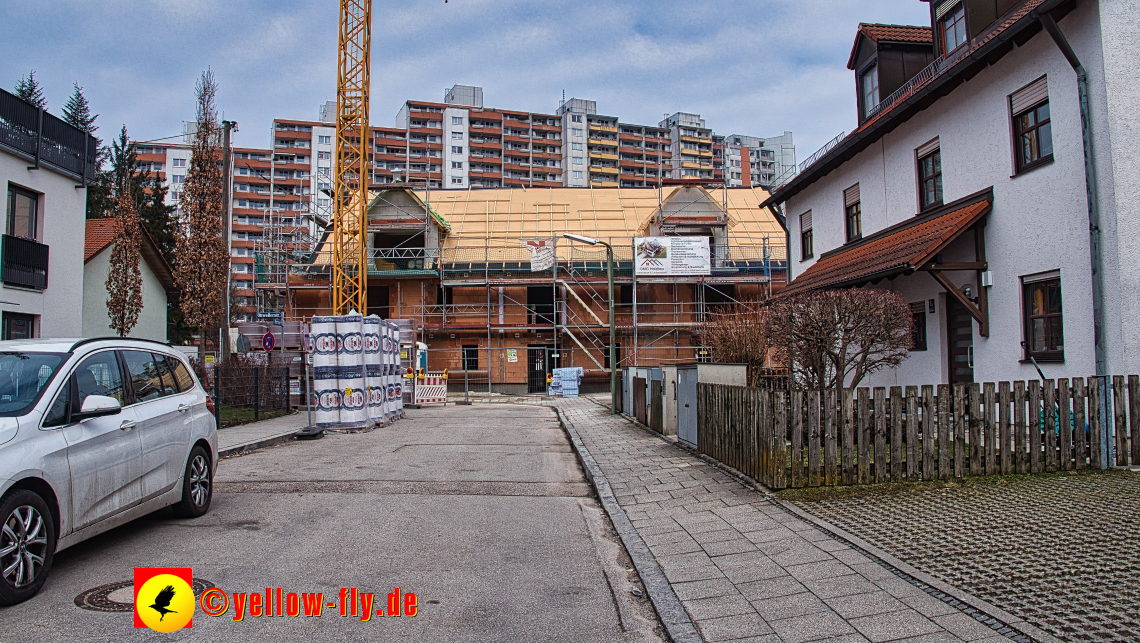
left=697, top=375, right=1140, bottom=489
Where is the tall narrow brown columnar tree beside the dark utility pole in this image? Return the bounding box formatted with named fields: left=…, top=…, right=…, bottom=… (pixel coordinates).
left=174, top=71, right=229, bottom=361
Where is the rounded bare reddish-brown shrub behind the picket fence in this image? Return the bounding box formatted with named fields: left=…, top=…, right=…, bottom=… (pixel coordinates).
left=768, top=288, right=913, bottom=389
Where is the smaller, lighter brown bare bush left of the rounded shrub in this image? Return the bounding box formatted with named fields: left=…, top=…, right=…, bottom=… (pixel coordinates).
left=701, top=302, right=770, bottom=386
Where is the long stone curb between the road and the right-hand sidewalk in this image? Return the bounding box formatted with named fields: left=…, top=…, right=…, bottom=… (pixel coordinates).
left=553, top=406, right=705, bottom=643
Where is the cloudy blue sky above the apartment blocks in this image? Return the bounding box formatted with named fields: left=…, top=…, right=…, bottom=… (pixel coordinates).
left=0, top=0, right=928, bottom=158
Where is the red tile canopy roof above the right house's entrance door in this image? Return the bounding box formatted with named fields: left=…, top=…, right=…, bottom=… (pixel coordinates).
left=781, top=198, right=990, bottom=294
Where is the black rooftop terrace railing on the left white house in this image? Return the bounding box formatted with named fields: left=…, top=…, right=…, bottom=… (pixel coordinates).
left=0, top=89, right=99, bottom=185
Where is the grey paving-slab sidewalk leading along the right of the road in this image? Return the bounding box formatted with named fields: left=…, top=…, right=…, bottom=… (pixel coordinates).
left=545, top=398, right=1024, bottom=643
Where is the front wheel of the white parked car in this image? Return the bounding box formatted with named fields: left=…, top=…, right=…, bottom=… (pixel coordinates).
left=0, top=489, right=56, bottom=605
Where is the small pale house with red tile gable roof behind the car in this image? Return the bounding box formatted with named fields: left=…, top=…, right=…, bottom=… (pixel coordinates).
left=83, top=219, right=178, bottom=342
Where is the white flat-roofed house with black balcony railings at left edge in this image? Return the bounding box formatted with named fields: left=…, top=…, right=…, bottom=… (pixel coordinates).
left=0, top=90, right=97, bottom=340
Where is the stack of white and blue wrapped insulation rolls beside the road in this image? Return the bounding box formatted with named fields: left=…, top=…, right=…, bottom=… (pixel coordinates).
left=310, top=314, right=404, bottom=430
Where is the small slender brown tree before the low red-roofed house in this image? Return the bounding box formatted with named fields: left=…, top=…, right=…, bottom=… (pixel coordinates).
left=106, top=189, right=143, bottom=337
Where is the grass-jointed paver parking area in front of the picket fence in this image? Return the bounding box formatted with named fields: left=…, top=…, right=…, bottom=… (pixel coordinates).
left=796, top=471, right=1140, bottom=642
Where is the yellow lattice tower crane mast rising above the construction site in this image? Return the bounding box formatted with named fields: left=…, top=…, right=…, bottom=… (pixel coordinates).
left=333, top=0, right=372, bottom=315
